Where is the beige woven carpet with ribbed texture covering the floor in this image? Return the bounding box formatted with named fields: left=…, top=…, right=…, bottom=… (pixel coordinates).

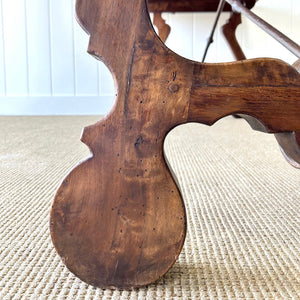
left=0, top=117, right=300, bottom=300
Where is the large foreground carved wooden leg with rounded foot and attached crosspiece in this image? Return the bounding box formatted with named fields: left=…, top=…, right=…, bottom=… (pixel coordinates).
left=50, top=0, right=300, bottom=288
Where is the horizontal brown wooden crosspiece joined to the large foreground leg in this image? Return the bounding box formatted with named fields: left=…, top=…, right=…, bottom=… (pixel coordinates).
left=188, top=59, right=300, bottom=133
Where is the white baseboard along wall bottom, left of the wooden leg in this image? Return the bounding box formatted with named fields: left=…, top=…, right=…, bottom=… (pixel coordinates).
left=0, top=95, right=114, bottom=116
